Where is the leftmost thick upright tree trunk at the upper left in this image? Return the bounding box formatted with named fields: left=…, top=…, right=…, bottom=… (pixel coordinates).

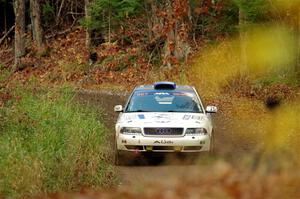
left=13, top=0, right=25, bottom=70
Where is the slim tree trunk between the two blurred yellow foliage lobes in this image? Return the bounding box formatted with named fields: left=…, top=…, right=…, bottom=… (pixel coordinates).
left=239, top=9, right=248, bottom=73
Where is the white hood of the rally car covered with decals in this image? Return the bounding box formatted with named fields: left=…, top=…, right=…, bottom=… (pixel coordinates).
left=118, top=112, right=208, bottom=127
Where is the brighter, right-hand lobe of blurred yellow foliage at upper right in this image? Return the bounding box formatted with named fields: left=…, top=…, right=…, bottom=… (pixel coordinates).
left=245, top=25, right=297, bottom=75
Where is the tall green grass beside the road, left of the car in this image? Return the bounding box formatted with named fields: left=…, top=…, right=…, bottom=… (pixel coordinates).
left=0, top=89, right=116, bottom=198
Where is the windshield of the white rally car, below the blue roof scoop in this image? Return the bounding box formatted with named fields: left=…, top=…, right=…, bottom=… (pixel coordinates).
left=126, top=91, right=203, bottom=113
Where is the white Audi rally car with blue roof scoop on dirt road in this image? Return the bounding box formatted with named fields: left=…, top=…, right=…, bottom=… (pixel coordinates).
left=114, top=82, right=217, bottom=164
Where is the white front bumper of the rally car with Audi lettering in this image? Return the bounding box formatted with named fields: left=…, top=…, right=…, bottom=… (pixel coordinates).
left=117, top=134, right=211, bottom=152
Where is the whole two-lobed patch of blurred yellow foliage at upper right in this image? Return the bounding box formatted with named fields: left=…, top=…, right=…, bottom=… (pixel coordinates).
left=188, top=26, right=297, bottom=96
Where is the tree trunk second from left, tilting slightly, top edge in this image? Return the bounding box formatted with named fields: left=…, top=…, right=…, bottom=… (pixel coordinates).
left=30, top=0, right=43, bottom=51
